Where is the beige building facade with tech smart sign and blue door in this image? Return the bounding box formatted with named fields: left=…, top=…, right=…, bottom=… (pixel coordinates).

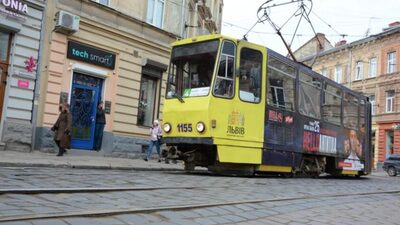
left=33, top=0, right=223, bottom=157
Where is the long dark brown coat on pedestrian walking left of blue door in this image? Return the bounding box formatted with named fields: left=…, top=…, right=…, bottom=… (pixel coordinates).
left=51, top=111, right=72, bottom=148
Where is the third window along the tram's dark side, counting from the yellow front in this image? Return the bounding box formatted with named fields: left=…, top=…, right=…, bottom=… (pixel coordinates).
left=322, top=84, right=342, bottom=125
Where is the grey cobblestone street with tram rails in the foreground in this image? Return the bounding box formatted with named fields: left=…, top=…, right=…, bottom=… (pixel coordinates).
left=0, top=168, right=400, bottom=225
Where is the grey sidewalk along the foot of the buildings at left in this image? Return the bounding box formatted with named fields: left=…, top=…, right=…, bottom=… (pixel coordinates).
left=0, top=150, right=183, bottom=171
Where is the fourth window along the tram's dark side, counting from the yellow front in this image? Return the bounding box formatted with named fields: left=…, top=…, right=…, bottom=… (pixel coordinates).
left=343, top=93, right=359, bottom=130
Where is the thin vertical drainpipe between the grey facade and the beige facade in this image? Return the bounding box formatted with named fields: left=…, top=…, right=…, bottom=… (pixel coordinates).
left=31, top=4, right=47, bottom=151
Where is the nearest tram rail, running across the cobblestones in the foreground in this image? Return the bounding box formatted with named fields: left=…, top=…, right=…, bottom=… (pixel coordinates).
left=0, top=190, right=400, bottom=222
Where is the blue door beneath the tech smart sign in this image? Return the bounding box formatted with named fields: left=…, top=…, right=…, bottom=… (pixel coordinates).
left=70, top=73, right=103, bottom=150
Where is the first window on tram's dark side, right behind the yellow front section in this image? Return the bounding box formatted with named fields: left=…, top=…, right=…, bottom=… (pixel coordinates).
left=267, top=57, right=296, bottom=111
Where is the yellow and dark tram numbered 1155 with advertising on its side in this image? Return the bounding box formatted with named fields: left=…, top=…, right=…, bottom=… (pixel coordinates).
left=163, top=34, right=371, bottom=176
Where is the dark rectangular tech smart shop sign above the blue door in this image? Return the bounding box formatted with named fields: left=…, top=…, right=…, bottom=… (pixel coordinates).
left=67, top=41, right=115, bottom=70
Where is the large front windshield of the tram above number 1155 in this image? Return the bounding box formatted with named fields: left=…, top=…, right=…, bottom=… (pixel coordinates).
left=166, top=40, right=219, bottom=101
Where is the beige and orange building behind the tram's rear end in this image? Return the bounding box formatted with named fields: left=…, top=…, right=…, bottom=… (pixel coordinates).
left=296, top=22, right=400, bottom=167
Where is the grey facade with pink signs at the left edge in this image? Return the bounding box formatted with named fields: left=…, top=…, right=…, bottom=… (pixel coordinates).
left=0, top=0, right=46, bottom=151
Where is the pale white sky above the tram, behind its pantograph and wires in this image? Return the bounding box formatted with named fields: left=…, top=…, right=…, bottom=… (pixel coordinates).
left=222, top=0, right=400, bottom=55
